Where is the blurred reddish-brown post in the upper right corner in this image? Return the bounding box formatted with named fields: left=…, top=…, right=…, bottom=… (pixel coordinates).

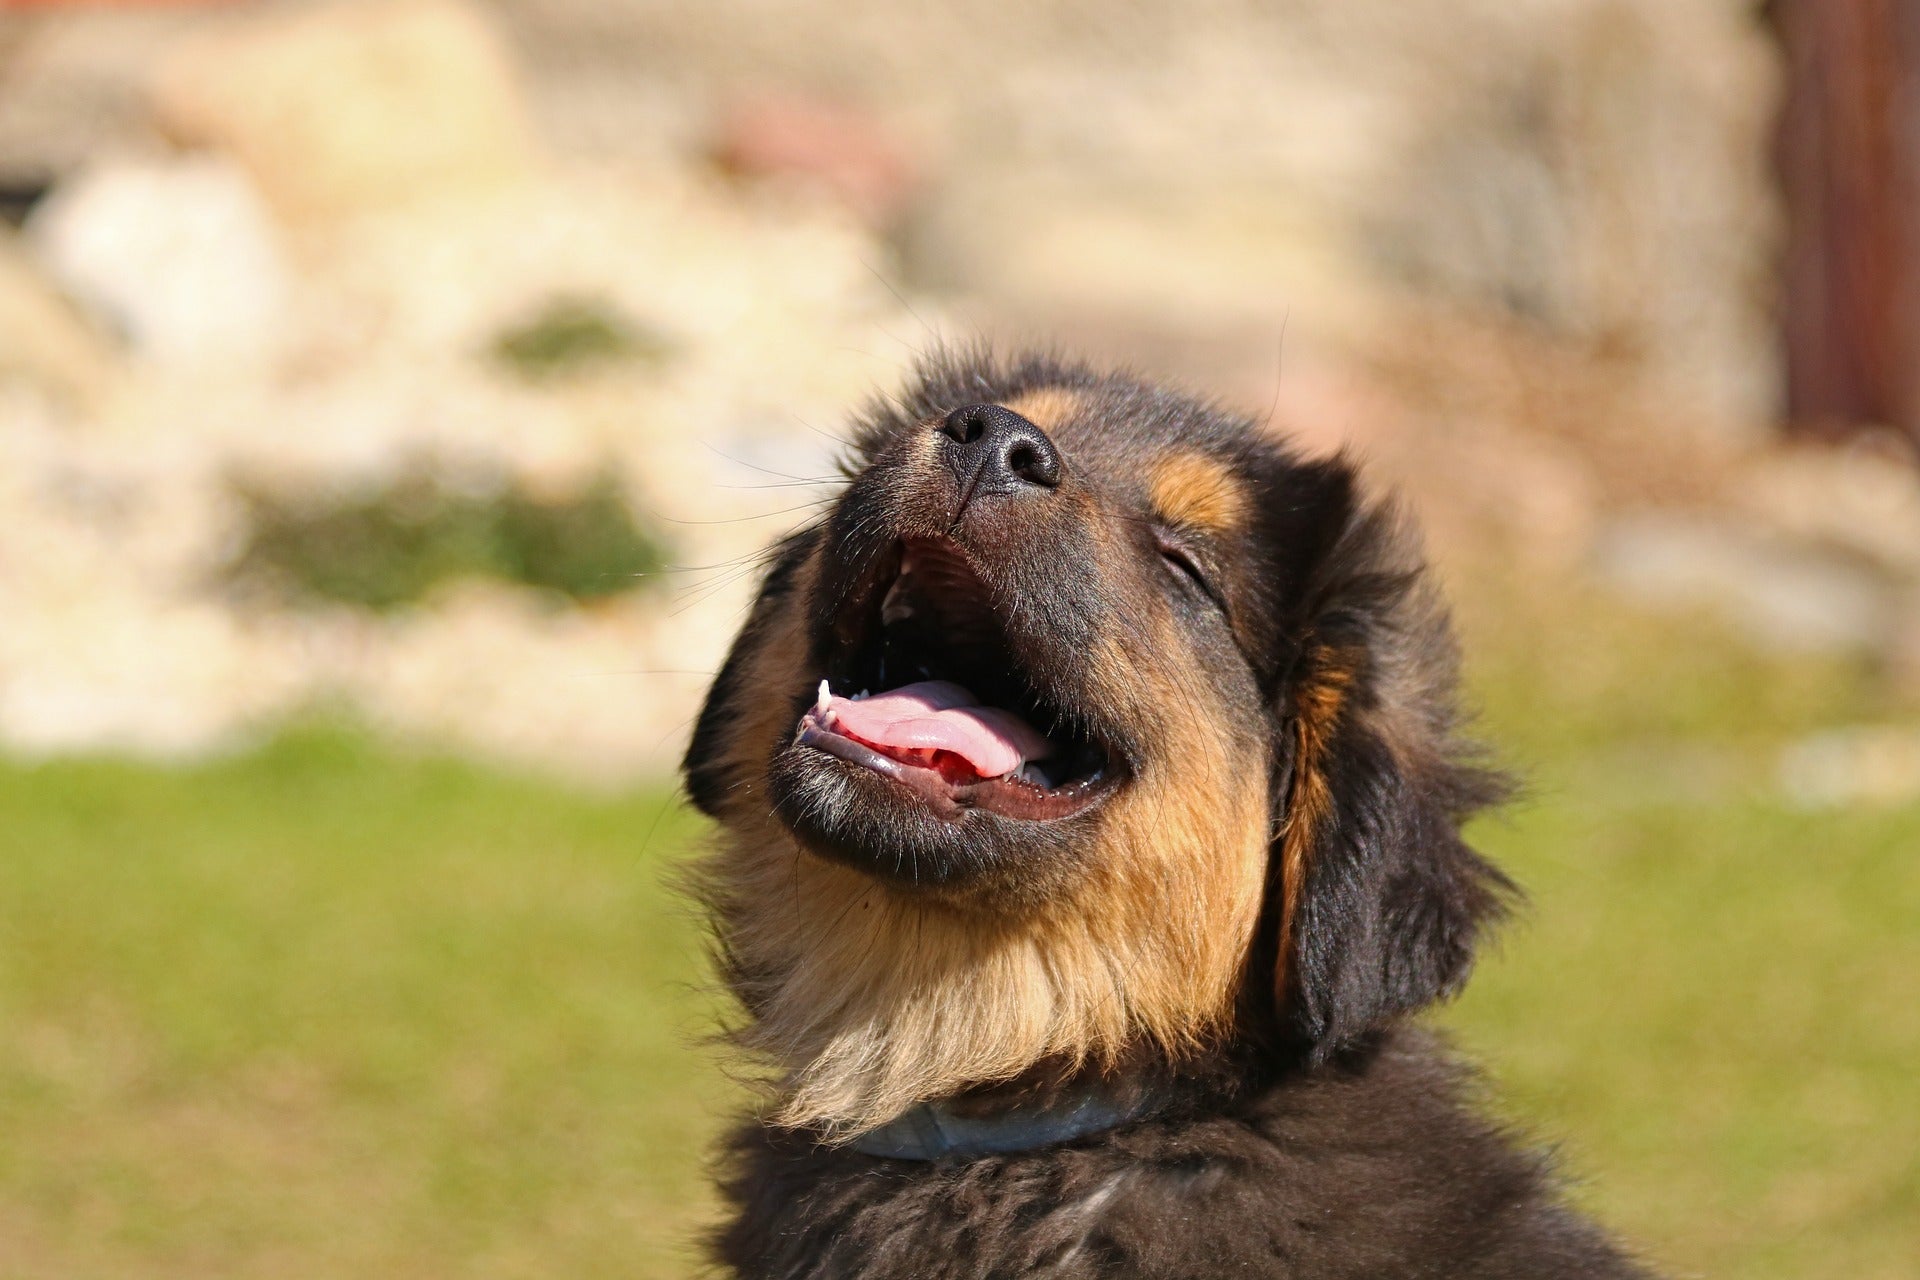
left=1770, top=0, right=1920, bottom=441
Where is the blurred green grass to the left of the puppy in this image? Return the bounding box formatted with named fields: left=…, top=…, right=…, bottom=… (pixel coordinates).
left=0, top=737, right=728, bottom=1280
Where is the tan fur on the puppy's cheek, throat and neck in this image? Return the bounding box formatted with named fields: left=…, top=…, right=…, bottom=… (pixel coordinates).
left=707, top=604, right=1269, bottom=1136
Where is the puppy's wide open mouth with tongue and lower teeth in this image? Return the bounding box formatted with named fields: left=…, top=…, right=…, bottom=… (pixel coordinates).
left=795, top=539, right=1121, bottom=821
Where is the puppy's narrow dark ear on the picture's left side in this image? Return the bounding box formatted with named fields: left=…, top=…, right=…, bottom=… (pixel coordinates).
left=680, top=530, right=816, bottom=818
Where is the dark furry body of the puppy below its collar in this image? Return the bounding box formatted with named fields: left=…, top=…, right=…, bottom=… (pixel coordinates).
left=716, top=1032, right=1647, bottom=1280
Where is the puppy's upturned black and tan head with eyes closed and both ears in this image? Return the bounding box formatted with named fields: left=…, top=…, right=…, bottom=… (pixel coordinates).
left=685, top=347, right=1503, bottom=1134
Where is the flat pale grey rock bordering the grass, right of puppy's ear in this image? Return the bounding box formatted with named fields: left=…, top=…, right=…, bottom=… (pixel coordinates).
left=1597, top=514, right=1895, bottom=654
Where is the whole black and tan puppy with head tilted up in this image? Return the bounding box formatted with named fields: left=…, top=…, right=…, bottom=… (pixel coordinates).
left=685, top=353, right=1645, bottom=1280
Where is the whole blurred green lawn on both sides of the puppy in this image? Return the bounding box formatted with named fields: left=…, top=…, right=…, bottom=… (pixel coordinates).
left=0, top=595, right=1920, bottom=1280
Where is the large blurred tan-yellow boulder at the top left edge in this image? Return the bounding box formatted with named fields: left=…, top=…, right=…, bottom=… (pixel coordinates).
left=152, top=0, right=534, bottom=217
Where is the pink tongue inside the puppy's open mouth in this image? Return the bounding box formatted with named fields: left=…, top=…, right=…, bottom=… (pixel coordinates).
left=814, top=679, right=1054, bottom=777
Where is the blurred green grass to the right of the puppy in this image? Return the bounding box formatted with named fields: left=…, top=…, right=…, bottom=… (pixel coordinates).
left=1444, top=593, right=1920, bottom=1280
